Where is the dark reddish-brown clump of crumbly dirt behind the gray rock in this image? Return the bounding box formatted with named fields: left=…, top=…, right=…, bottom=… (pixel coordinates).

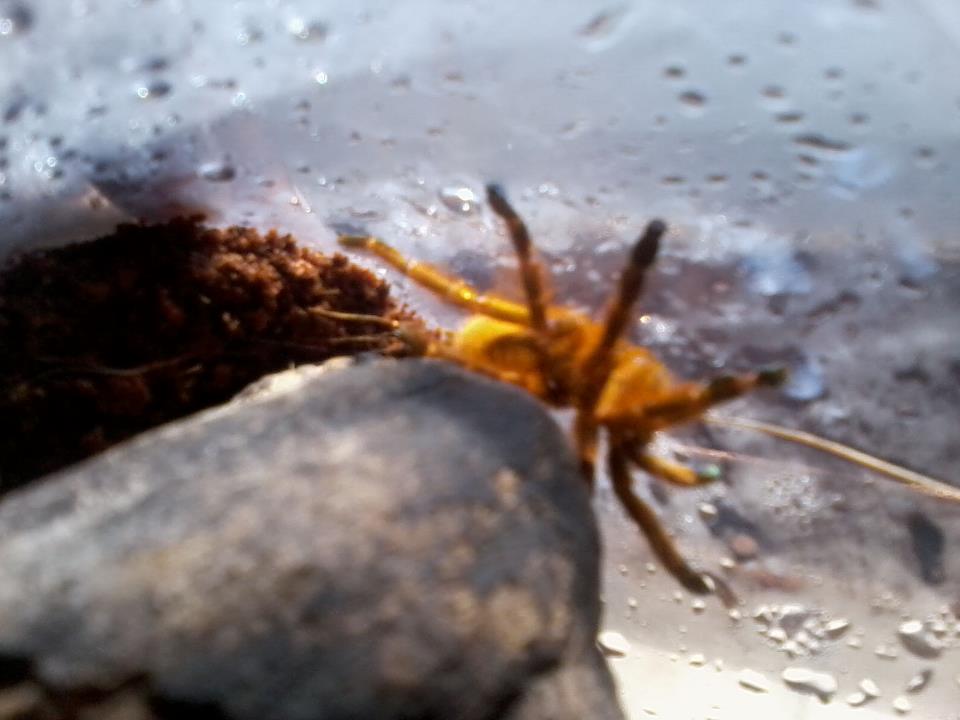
left=0, top=218, right=409, bottom=493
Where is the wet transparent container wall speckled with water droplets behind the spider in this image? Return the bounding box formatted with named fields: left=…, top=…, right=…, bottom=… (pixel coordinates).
left=0, top=0, right=960, bottom=719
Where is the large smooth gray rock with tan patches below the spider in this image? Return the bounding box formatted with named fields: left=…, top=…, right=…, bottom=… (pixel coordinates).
left=0, top=361, right=622, bottom=720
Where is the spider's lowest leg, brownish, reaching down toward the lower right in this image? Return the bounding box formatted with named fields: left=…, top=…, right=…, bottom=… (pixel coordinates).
left=607, top=441, right=737, bottom=607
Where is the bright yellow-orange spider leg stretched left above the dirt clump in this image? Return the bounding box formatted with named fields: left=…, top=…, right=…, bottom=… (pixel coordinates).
left=337, top=235, right=531, bottom=325
